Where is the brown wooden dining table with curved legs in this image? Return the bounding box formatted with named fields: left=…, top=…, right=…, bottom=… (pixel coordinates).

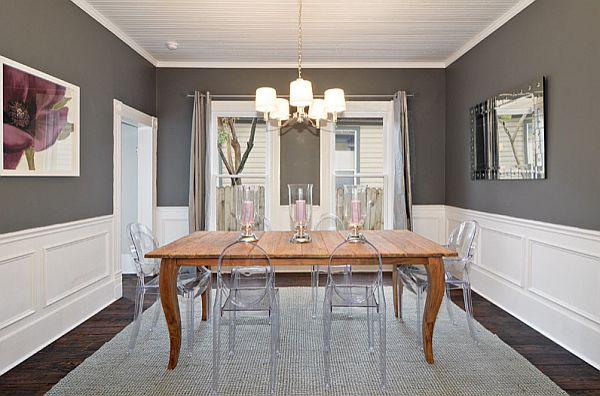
left=146, top=230, right=456, bottom=369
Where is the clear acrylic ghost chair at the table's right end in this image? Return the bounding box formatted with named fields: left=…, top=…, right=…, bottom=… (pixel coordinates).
left=397, top=220, right=479, bottom=345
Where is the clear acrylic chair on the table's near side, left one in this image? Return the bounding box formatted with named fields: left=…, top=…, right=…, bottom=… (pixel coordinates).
left=212, top=241, right=280, bottom=394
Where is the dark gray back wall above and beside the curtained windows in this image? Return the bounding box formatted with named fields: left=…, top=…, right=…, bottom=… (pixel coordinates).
left=156, top=68, right=446, bottom=206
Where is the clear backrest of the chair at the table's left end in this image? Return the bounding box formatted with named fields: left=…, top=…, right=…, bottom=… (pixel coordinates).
left=127, top=223, right=160, bottom=278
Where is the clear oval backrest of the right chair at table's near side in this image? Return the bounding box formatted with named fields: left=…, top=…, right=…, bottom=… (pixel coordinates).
left=327, top=240, right=383, bottom=305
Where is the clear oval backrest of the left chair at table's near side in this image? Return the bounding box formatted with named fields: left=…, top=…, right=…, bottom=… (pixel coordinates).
left=217, top=241, right=275, bottom=308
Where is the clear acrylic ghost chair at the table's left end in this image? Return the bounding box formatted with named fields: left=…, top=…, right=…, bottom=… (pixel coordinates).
left=127, top=223, right=211, bottom=355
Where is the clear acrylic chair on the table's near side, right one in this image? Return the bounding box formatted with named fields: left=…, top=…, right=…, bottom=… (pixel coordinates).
left=323, top=240, right=386, bottom=388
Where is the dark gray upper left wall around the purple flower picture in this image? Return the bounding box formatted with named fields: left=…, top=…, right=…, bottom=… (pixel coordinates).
left=0, top=0, right=156, bottom=233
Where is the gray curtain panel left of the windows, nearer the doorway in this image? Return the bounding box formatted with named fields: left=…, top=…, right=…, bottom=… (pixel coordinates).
left=189, top=91, right=210, bottom=233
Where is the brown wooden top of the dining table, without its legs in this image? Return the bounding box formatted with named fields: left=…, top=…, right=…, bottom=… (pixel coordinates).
left=146, top=230, right=456, bottom=265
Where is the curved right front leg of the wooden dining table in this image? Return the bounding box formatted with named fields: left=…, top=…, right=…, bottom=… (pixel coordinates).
left=422, top=257, right=445, bottom=363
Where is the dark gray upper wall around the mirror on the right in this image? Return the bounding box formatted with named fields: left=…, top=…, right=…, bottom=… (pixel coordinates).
left=446, top=0, right=600, bottom=230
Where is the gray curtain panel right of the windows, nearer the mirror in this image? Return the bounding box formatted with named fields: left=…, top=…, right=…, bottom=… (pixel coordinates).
left=392, top=91, right=413, bottom=230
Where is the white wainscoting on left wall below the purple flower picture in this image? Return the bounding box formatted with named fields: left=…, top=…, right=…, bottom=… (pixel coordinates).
left=0, top=215, right=116, bottom=375
